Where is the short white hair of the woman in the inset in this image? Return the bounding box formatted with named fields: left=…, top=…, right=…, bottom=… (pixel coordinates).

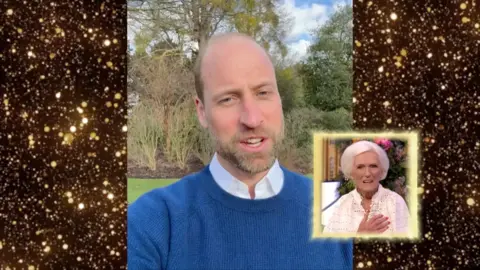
left=340, top=141, right=390, bottom=180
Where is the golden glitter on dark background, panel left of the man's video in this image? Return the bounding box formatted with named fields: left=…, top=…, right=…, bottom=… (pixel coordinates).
left=0, top=0, right=127, bottom=269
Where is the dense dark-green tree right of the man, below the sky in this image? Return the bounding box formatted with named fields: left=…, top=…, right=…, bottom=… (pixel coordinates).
left=300, top=6, right=353, bottom=111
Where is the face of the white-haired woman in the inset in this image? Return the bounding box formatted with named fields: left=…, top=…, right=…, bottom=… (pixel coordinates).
left=351, top=151, right=383, bottom=192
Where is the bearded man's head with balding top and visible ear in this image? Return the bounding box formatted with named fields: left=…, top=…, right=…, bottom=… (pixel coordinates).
left=197, top=40, right=283, bottom=174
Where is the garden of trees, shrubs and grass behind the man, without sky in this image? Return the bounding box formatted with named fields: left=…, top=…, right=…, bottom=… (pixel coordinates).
left=128, top=0, right=354, bottom=202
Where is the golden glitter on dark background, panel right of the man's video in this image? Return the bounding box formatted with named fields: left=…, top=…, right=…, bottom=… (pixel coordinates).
left=353, top=0, right=480, bottom=269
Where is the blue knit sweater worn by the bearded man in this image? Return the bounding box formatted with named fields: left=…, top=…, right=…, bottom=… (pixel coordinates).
left=128, top=166, right=353, bottom=270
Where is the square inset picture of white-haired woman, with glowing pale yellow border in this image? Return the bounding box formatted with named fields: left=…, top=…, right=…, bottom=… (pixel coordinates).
left=313, top=132, right=419, bottom=239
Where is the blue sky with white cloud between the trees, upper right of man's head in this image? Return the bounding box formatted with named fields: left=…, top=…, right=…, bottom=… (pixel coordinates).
left=129, top=0, right=352, bottom=60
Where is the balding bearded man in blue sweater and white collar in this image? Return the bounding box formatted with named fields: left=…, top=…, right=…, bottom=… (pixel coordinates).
left=128, top=33, right=353, bottom=270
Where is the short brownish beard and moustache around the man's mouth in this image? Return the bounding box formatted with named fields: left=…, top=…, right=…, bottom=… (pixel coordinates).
left=209, top=123, right=284, bottom=174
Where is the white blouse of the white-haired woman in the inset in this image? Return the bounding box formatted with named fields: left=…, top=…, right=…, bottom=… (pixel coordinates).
left=325, top=184, right=410, bottom=234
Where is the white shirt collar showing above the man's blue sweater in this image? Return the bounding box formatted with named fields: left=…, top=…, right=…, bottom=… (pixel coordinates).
left=209, top=153, right=283, bottom=200
